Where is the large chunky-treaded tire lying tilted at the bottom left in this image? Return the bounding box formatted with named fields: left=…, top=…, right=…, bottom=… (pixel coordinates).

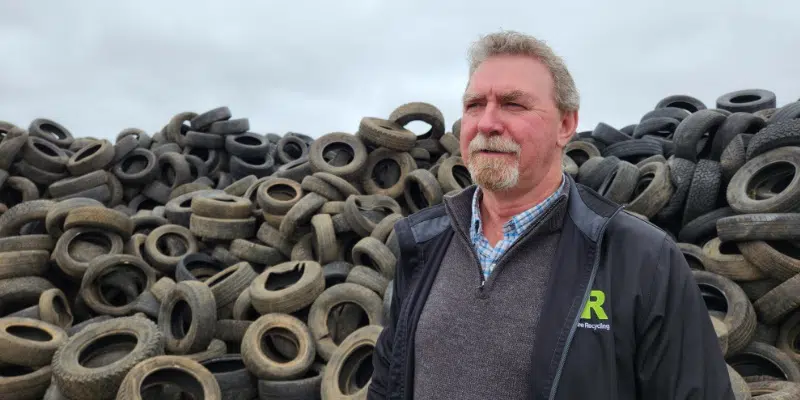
left=52, top=316, right=164, bottom=400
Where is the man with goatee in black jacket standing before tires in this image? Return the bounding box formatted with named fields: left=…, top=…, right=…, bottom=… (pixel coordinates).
left=368, top=32, right=733, bottom=400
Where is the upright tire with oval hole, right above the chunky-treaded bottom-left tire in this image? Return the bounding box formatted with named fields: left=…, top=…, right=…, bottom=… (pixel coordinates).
left=158, top=281, right=217, bottom=354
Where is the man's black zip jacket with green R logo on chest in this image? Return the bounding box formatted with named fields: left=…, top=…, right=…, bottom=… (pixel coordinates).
left=367, top=176, right=734, bottom=400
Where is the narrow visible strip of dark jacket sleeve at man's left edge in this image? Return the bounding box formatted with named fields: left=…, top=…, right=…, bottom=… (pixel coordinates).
left=367, top=233, right=404, bottom=400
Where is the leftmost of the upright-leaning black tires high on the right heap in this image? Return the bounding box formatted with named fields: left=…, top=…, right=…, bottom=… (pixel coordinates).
left=673, top=110, right=726, bottom=162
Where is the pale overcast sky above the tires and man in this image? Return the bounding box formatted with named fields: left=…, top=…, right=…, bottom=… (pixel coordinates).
left=0, top=0, right=800, bottom=139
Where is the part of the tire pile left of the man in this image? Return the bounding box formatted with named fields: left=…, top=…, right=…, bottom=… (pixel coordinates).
left=0, top=102, right=471, bottom=400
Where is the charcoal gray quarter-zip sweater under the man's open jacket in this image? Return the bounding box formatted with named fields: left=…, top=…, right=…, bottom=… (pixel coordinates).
left=414, top=188, right=569, bottom=400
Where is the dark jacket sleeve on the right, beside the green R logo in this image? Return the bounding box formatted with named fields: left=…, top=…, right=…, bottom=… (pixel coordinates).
left=635, top=237, right=734, bottom=400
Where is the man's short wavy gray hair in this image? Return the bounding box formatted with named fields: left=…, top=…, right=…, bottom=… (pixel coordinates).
left=469, top=31, right=580, bottom=113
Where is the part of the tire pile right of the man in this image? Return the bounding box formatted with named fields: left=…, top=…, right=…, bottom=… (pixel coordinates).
left=564, top=89, right=800, bottom=399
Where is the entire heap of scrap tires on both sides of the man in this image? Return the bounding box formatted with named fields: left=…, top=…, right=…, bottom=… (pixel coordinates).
left=0, top=89, right=800, bottom=400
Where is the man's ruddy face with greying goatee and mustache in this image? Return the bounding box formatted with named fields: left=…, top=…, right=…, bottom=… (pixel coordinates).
left=461, top=56, right=571, bottom=191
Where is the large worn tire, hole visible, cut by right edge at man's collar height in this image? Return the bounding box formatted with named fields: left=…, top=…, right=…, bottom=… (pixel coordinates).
left=726, top=146, right=800, bottom=214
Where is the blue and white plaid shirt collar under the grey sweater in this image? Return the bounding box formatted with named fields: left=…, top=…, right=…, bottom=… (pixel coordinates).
left=470, top=179, right=567, bottom=284
